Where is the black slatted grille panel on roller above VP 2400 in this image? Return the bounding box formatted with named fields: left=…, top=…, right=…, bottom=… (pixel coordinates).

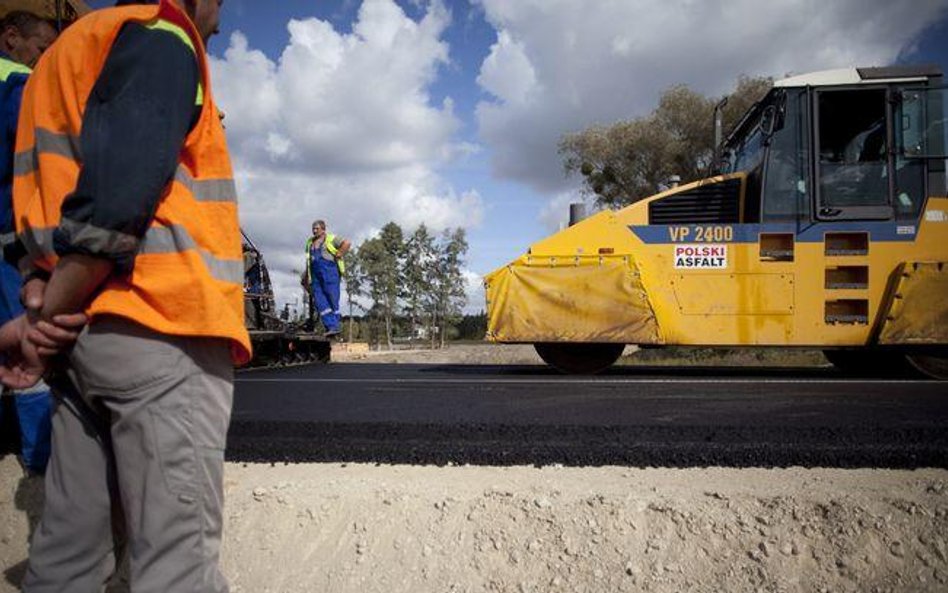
left=648, top=178, right=741, bottom=224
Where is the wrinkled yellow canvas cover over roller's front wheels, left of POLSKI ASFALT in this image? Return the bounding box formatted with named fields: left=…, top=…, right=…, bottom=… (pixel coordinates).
left=485, top=256, right=660, bottom=344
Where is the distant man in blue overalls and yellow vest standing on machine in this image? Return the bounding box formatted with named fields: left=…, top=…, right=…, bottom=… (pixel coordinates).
left=305, top=220, right=351, bottom=338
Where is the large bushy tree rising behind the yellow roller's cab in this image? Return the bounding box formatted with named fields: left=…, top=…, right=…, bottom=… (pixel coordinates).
left=559, top=76, right=773, bottom=208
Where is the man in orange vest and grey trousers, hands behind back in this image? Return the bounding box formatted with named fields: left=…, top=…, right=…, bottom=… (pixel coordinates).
left=13, top=0, right=251, bottom=593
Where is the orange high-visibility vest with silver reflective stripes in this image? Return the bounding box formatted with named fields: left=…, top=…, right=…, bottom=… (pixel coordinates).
left=13, top=0, right=251, bottom=364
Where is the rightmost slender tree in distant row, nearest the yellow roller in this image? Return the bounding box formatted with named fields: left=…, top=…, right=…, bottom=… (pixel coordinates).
left=430, top=228, right=468, bottom=348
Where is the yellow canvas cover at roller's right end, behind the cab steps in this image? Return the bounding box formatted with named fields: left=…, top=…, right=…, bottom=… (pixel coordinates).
left=879, top=262, right=948, bottom=344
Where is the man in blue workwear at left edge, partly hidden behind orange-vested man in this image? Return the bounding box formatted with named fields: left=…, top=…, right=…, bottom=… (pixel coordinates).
left=0, top=10, right=56, bottom=474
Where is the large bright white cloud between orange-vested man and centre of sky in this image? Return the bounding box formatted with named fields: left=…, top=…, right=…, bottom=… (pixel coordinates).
left=211, top=0, right=483, bottom=302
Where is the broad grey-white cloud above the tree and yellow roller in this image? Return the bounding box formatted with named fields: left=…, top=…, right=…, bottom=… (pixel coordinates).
left=474, top=0, right=948, bottom=193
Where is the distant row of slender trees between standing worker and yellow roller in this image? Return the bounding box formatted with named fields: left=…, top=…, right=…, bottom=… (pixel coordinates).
left=346, top=222, right=468, bottom=348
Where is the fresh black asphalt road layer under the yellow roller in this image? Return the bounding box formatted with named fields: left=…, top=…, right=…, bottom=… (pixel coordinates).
left=227, top=363, right=948, bottom=468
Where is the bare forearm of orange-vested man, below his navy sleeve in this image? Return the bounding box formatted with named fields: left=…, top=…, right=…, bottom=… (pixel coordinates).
left=41, top=254, right=114, bottom=319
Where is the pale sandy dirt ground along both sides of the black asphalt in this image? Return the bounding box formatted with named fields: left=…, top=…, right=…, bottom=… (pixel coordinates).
left=0, top=347, right=948, bottom=593
